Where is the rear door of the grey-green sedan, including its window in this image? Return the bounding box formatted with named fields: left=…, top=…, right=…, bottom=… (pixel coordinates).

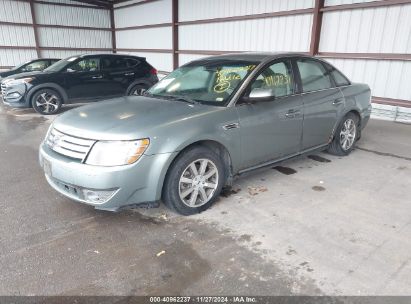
left=295, top=58, right=344, bottom=150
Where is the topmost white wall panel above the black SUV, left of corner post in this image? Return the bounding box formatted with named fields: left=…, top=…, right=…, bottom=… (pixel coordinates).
left=34, top=2, right=110, bottom=28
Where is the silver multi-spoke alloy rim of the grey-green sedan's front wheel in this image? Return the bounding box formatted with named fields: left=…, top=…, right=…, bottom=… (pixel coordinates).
left=179, top=159, right=219, bottom=208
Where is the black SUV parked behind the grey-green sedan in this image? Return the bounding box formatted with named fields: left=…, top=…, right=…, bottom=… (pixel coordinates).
left=1, top=54, right=158, bottom=115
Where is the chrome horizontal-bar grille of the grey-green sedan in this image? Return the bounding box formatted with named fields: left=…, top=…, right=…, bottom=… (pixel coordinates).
left=46, top=129, right=96, bottom=161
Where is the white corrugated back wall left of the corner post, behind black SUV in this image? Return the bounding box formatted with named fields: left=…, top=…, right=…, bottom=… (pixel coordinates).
left=0, top=0, right=112, bottom=69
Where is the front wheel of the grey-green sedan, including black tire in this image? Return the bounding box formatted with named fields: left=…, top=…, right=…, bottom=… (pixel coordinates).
left=163, top=147, right=225, bottom=215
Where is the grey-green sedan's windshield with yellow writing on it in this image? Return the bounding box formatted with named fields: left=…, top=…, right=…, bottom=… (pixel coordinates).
left=146, top=60, right=258, bottom=106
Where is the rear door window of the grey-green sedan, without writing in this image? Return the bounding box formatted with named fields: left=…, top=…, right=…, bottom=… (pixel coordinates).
left=297, top=59, right=333, bottom=92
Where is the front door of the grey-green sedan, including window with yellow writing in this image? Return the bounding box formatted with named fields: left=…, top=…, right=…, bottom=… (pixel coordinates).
left=236, top=60, right=303, bottom=169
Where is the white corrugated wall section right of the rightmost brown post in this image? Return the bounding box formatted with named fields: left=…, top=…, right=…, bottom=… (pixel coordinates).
left=319, top=0, right=411, bottom=119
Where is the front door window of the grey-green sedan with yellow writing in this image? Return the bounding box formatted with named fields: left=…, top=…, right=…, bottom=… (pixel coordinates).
left=251, top=61, right=294, bottom=97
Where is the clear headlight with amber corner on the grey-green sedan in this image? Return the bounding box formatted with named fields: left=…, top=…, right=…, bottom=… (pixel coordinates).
left=86, top=138, right=150, bottom=167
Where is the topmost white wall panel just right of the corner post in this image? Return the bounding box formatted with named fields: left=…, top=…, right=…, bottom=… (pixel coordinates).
left=114, top=0, right=172, bottom=28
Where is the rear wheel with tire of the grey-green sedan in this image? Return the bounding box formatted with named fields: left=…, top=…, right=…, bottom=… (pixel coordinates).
left=327, top=113, right=360, bottom=156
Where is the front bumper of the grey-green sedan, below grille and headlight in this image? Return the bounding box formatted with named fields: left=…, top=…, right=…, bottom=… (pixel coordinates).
left=39, top=143, right=177, bottom=211
